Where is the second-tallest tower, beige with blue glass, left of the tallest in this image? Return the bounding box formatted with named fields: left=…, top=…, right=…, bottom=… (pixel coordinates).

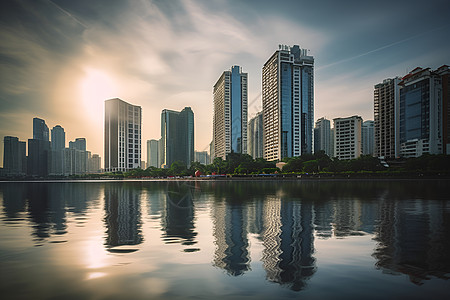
left=213, top=66, right=247, bottom=159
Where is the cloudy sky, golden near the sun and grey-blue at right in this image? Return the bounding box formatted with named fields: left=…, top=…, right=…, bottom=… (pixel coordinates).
left=0, top=0, right=450, bottom=165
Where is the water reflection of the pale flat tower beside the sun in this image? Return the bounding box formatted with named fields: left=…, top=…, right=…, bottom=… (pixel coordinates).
left=104, top=184, right=143, bottom=252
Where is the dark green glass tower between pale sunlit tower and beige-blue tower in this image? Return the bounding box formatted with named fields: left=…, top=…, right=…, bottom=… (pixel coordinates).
left=160, top=107, right=194, bottom=168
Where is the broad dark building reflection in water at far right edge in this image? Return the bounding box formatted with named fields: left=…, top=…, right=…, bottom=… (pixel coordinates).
left=373, top=195, right=450, bottom=285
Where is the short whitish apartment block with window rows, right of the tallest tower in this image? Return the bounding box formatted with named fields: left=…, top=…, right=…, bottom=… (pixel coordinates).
left=333, top=116, right=362, bottom=159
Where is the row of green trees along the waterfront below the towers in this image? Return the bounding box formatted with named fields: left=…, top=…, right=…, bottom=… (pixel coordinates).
left=63, top=151, right=450, bottom=178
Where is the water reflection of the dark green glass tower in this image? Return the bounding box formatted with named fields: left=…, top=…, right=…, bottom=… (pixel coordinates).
left=161, top=181, right=198, bottom=246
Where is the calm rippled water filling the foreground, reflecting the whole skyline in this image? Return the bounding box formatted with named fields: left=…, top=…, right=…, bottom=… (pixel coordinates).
left=0, top=181, right=450, bottom=299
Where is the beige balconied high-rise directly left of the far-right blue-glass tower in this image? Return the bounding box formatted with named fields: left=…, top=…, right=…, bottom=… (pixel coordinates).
left=373, top=77, right=400, bottom=159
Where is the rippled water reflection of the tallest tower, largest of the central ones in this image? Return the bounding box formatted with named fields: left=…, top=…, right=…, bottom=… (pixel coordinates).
left=262, top=190, right=317, bottom=291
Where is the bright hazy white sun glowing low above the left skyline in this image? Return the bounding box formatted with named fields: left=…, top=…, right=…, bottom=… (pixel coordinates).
left=80, top=67, right=117, bottom=120
